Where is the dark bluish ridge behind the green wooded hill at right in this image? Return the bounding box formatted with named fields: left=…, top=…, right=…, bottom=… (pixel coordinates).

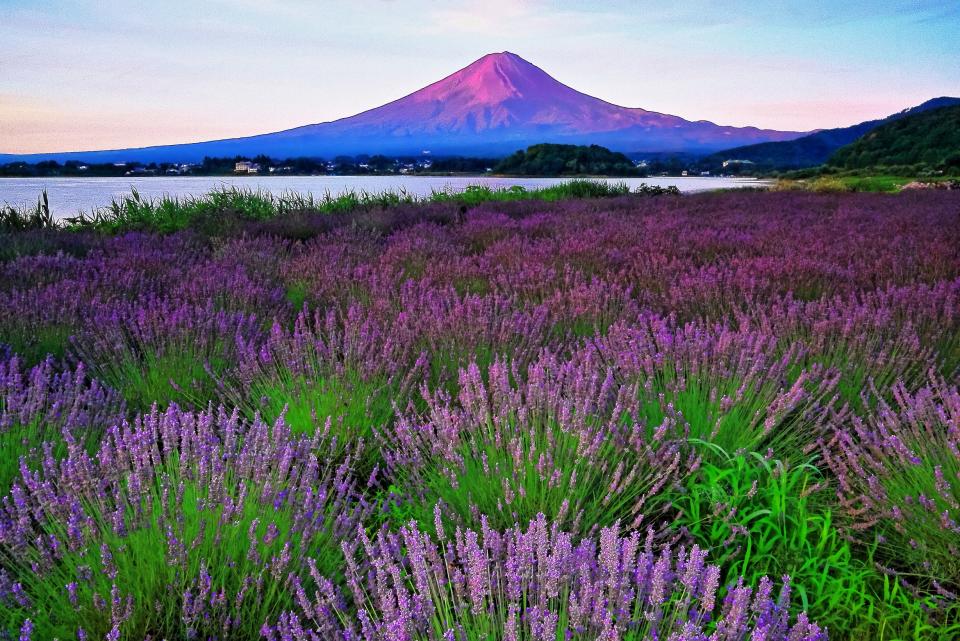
left=703, top=96, right=960, bottom=171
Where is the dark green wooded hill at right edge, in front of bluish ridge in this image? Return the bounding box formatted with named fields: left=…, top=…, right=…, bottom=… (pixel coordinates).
left=827, top=101, right=960, bottom=173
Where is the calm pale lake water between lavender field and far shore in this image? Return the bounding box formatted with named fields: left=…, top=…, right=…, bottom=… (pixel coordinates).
left=0, top=176, right=764, bottom=217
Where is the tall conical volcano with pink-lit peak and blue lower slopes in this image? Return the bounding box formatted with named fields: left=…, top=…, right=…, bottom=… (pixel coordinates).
left=0, top=51, right=802, bottom=162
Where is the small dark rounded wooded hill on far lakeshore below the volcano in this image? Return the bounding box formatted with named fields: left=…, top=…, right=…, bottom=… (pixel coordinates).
left=493, top=144, right=637, bottom=176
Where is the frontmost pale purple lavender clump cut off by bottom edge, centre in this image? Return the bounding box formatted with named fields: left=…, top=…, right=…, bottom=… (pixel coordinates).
left=263, top=514, right=827, bottom=641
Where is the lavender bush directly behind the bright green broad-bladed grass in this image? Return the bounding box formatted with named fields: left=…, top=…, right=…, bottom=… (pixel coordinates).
left=593, top=316, right=836, bottom=460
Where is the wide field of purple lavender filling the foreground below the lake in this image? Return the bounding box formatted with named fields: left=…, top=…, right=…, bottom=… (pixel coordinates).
left=0, top=190, right=960, bottom=641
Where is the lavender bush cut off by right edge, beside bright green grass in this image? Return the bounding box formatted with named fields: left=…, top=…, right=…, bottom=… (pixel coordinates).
left=823, top=378, right=960, bottom=600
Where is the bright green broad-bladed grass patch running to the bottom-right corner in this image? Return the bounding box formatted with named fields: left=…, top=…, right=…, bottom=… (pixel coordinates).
left=673, top=444, right=960, bottom=640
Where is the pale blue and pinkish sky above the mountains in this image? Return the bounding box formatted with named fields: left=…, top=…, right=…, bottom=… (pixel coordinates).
left=0, top=0, right=960, bottom=153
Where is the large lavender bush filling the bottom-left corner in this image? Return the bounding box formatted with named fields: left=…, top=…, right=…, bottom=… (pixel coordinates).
left=0, top=405, right=368, bottom=639
